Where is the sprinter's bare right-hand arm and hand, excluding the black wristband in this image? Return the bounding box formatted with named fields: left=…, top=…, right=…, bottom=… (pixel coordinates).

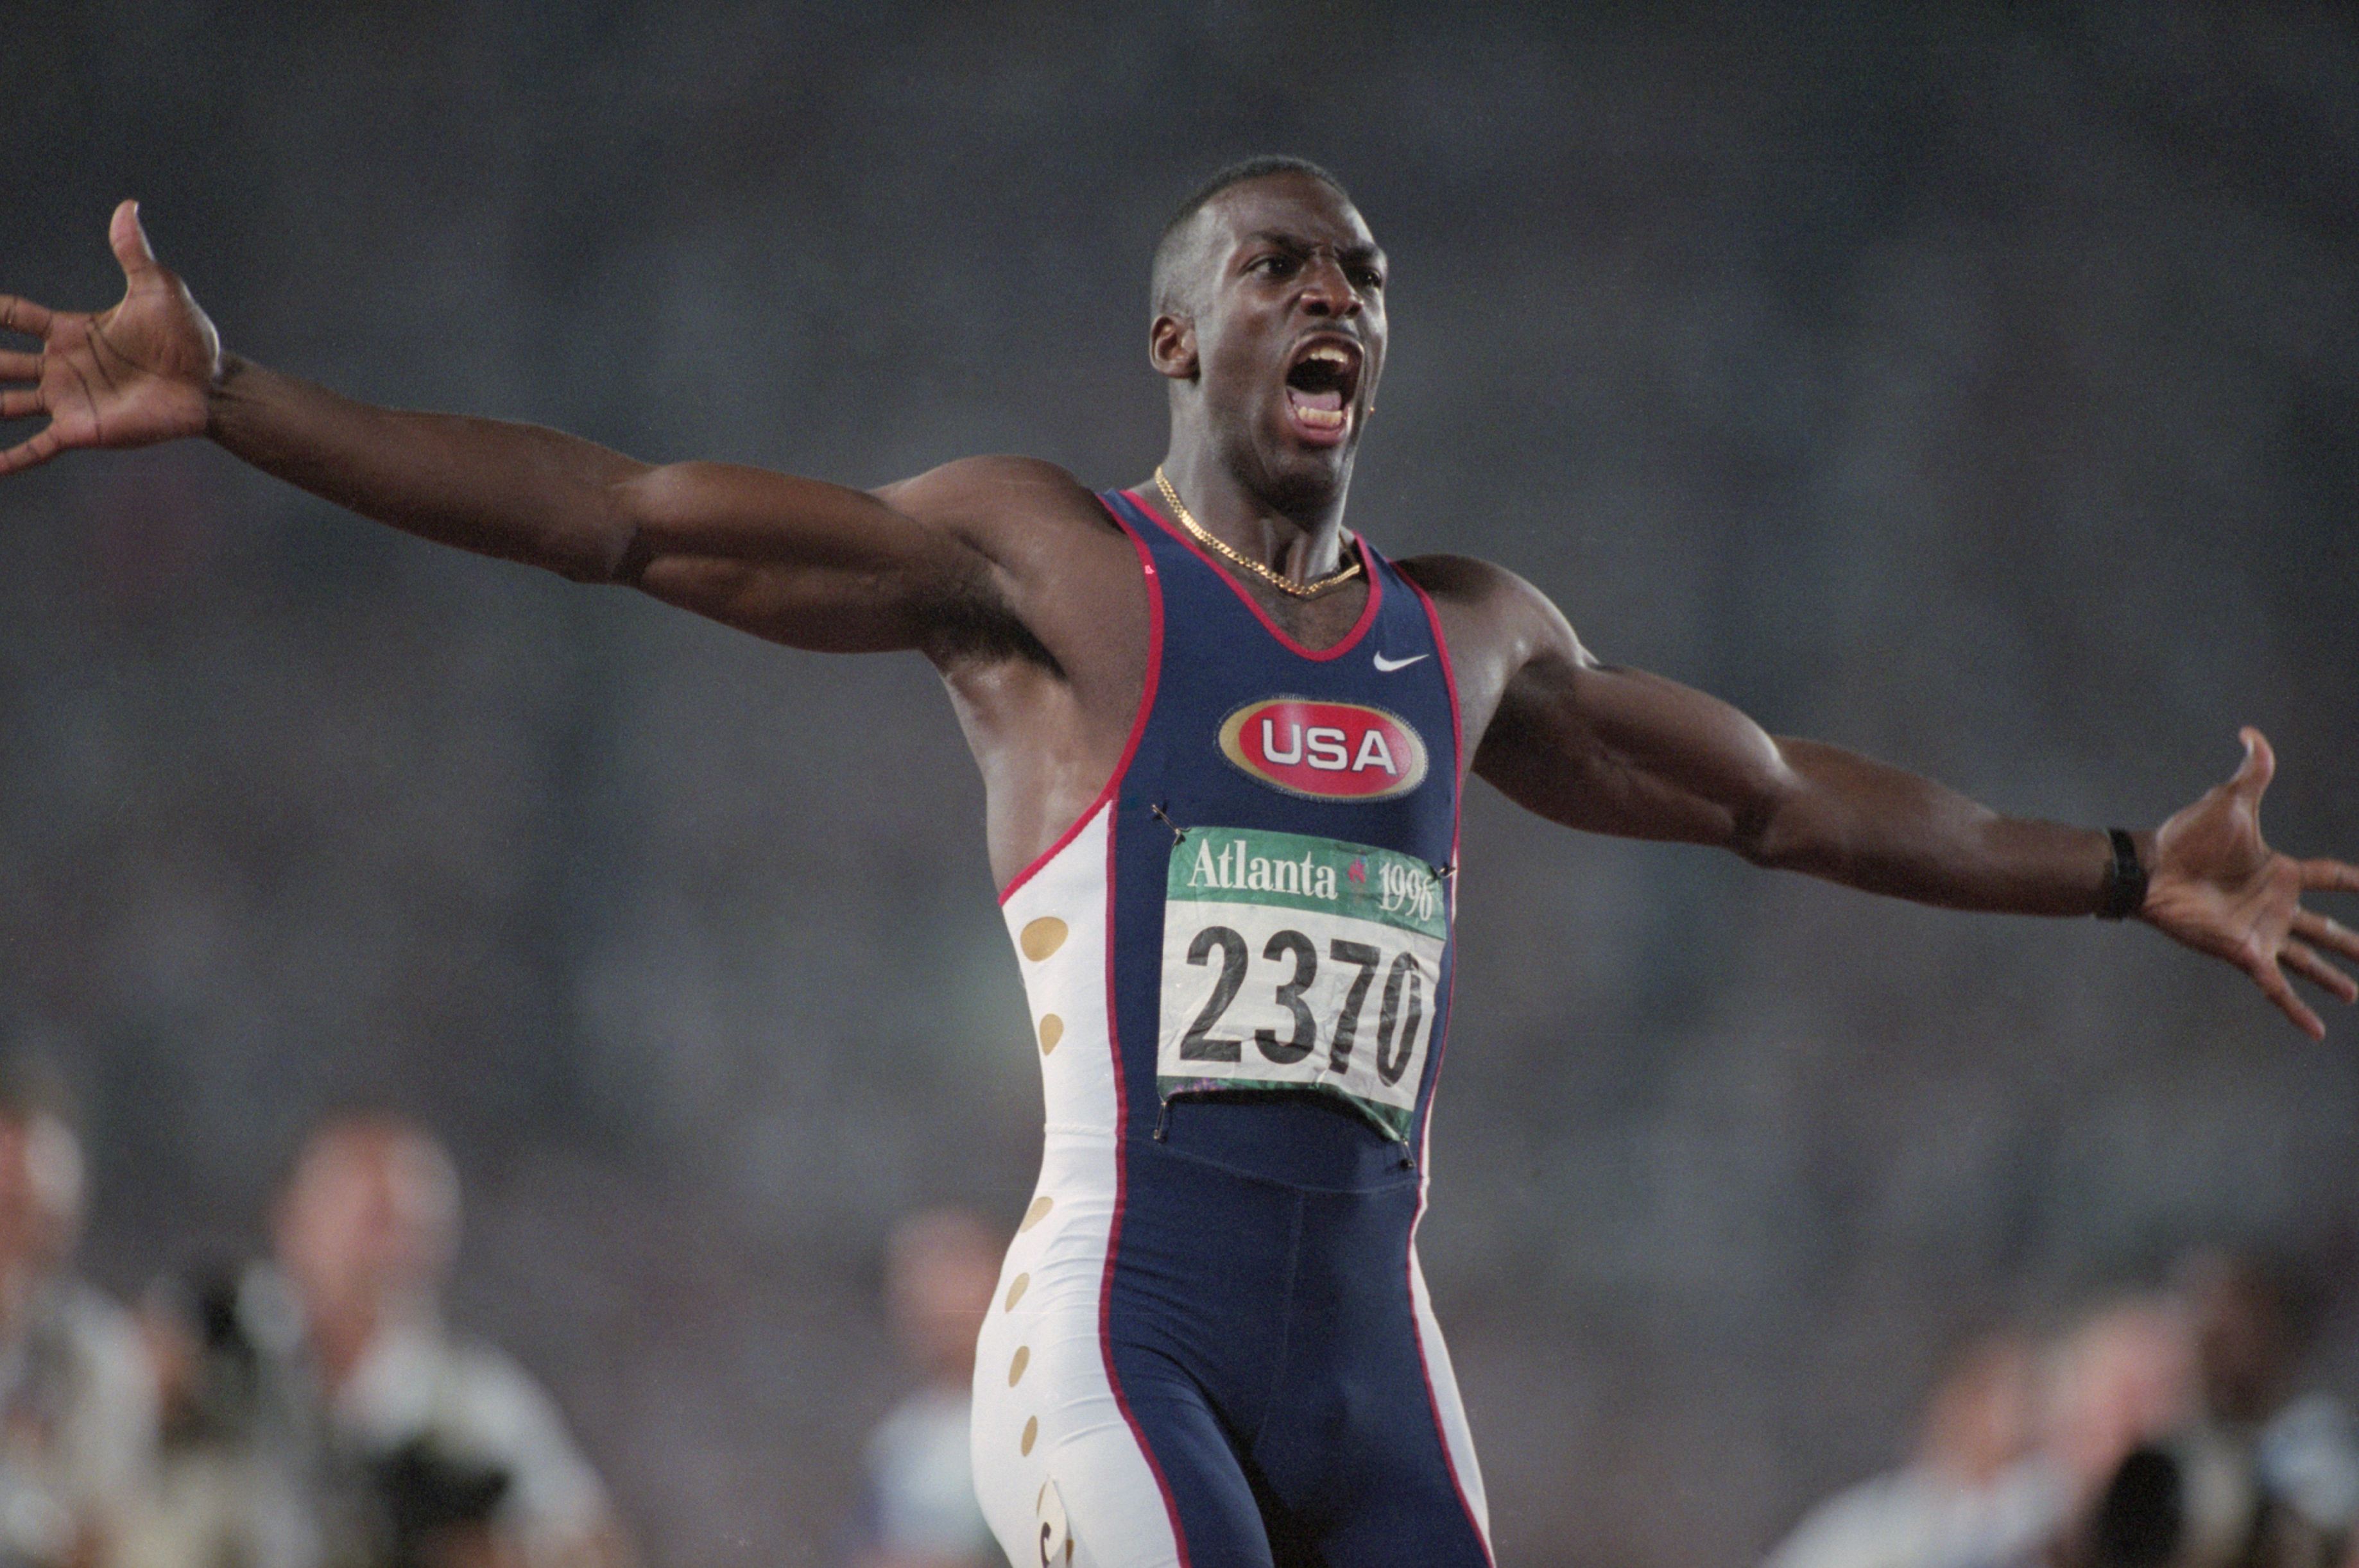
left=1455, top=563, right=2359, bottom=1037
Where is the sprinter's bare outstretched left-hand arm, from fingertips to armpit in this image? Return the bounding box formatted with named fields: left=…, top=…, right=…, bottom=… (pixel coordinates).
left=0, top=203, right=1014, bottom=651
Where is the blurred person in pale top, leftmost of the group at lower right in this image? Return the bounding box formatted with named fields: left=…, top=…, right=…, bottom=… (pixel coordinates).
left=1765, top=1332, right=2064, bottom=1568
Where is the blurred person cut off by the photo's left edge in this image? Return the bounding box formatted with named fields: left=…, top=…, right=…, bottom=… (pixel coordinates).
left=0, top=1061, right=156, bottom=1568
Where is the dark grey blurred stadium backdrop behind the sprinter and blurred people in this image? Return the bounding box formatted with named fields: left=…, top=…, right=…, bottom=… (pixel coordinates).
left=0, top=0, right=2359, bottom=1568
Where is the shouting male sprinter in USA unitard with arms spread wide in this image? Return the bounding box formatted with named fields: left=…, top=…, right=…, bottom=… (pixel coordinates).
left=0, top=160, right=2359, bottom=1568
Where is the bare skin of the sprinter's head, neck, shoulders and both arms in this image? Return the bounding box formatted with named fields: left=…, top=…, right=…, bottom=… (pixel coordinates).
left=13, top=172, right=2359, bottom=1035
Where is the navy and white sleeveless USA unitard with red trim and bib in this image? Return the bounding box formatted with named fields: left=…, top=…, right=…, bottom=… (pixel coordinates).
left=974, top=493, right=1489, bottom=1568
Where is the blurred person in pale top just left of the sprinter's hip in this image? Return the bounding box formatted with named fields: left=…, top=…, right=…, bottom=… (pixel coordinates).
left=852, top=1209, right=1008, bottom=1568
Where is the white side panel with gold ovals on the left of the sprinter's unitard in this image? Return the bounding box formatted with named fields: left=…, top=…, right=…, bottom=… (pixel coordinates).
left=974, top=802, right=1180, bottom=1568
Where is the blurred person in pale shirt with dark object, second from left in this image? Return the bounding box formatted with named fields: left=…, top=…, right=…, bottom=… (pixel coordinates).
left=273, top=1115, right=630, bottom=1568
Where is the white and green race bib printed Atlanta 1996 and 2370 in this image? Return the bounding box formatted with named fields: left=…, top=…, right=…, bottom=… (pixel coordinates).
left=1156, top=828, right=1448, bottom=1139
